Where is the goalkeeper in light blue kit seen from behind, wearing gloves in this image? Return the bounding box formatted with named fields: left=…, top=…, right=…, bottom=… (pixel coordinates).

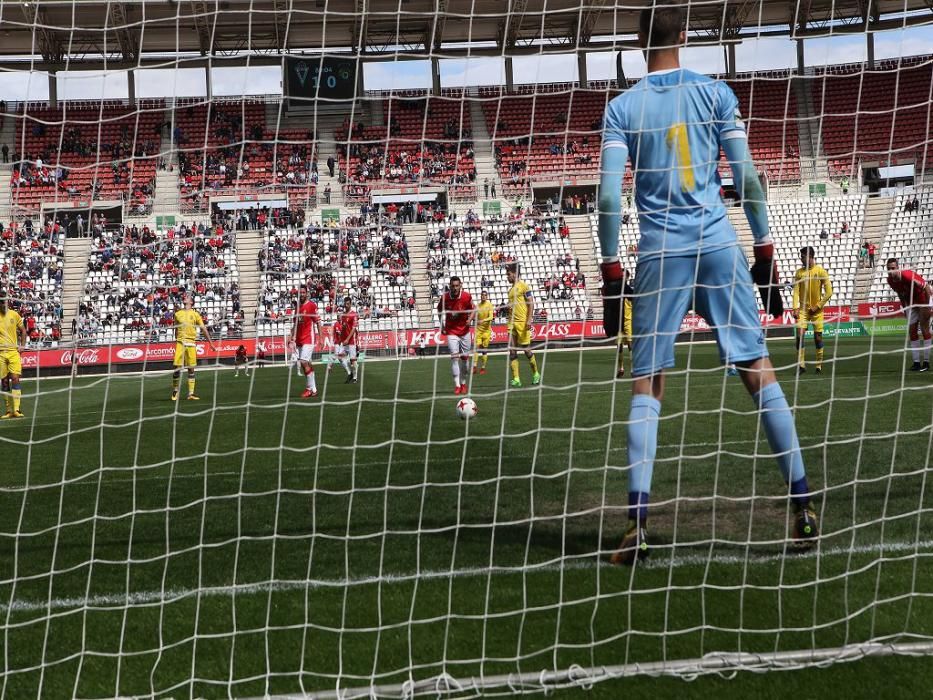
left=599, top=2, right=817, bottom=564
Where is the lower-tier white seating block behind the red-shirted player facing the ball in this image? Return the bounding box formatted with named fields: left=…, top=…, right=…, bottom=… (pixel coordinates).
left=427, top=210, right=590, bottom=326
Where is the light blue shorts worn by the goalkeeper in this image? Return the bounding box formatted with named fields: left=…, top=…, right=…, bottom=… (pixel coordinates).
left=632, top=245, right=768, bottom=377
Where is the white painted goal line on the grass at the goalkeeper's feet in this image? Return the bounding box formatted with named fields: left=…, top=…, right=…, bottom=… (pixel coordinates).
left=0, top=540, right=933, bottom=613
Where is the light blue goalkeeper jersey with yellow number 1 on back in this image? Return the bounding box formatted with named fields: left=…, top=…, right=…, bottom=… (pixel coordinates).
left=603, top=69, right=746, bottom=259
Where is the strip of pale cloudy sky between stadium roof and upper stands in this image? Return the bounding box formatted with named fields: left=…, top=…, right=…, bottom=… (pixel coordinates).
left=0, top=26, right=933, bottom=101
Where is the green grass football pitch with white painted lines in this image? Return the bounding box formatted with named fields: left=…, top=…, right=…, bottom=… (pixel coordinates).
left=0, top=338, right=933, bottom=698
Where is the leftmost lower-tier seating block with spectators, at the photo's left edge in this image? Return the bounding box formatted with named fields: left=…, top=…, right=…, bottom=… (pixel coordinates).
left=0, top=221, right=65, bottom=347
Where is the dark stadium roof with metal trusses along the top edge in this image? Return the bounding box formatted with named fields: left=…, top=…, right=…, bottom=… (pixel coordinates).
left=7, top=0, right=933, bottom=70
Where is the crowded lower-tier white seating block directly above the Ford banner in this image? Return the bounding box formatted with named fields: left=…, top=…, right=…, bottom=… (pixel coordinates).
left=78, top=225, right=243, bottom=344
